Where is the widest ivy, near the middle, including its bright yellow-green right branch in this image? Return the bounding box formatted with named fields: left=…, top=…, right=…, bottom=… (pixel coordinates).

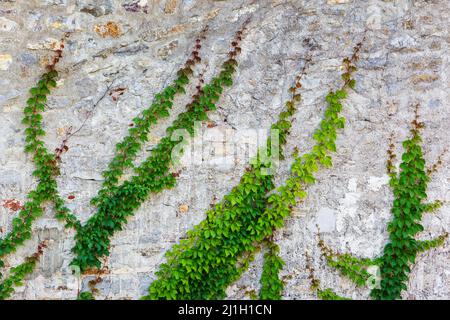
left=144, top=40, right=361, bottom=299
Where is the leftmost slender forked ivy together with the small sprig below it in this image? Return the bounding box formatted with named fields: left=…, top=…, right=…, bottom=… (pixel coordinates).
left=0, top=34, right=79, bottom=299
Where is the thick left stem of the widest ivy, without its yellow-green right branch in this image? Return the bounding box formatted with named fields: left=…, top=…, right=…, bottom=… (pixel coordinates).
left=144, top=65, right=300, bottom=299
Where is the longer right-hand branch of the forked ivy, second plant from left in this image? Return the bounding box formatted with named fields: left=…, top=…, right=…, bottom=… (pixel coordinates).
left=71, top=30, right=244, bottom=271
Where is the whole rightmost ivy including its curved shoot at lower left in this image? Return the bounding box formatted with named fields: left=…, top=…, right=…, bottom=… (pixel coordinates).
left=319, top=105, right=448, bottom=300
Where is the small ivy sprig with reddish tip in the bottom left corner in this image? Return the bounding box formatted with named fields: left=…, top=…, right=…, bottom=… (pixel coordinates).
left=0, top=242, right=46, bottom=300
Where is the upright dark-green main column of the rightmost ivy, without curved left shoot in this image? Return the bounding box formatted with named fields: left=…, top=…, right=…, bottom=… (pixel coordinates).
left=371, top=115, right=446, bottom=300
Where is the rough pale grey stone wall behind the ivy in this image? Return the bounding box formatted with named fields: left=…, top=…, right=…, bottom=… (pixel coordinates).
left=0, top=0, right=450, bottom=299
